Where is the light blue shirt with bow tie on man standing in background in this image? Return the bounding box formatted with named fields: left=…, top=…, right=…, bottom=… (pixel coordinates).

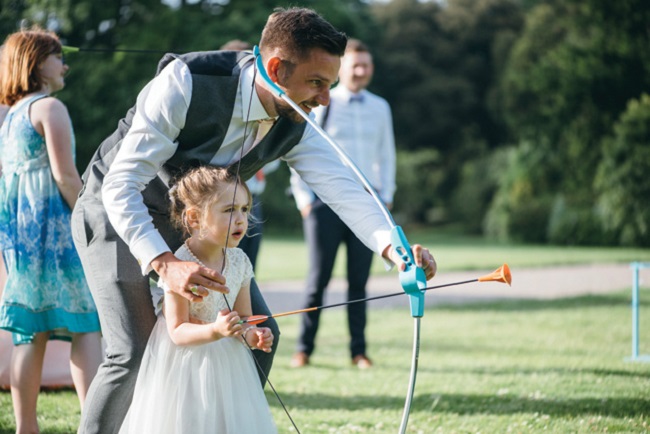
left=291, top=86, right=395, bottom=209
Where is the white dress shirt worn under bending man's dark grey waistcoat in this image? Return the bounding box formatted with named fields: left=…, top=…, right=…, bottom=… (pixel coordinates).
left=102, top=59, right=391, bottom=274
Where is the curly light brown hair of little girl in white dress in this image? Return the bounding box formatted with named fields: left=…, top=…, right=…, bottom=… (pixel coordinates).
left=169, top=166, right=253, bottom=235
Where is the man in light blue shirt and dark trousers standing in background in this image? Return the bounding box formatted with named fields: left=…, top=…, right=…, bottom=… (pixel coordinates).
left=291, top=39, right=395, bottom=369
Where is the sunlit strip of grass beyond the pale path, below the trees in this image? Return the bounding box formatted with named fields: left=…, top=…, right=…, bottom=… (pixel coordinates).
left=256, top=229, right=650, bottom=282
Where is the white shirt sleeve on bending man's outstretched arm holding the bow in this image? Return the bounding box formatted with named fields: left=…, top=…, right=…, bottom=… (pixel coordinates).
left=283, top=125, right=391, bottom=255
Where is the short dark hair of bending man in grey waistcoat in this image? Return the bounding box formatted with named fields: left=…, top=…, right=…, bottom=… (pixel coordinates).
left=260, top=8, right=348, bottom=61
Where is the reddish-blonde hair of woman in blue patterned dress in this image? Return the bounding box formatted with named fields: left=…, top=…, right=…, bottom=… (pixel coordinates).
left=0, top=27, right=62, bottom=106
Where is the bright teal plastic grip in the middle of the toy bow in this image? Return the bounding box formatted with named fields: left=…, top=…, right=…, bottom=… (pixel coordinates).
left=390, top=226, right=427, bottom=318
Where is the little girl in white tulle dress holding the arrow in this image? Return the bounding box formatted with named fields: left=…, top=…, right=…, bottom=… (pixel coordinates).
left=120, top=167, right=276, bottom=434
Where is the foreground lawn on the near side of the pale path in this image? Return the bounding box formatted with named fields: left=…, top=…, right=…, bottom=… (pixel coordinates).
left=0, top=290, right=650, bottom=434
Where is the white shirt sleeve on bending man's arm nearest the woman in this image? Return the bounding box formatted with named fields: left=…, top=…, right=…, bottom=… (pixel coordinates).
left=102, top=60, right=192, bottom=274
